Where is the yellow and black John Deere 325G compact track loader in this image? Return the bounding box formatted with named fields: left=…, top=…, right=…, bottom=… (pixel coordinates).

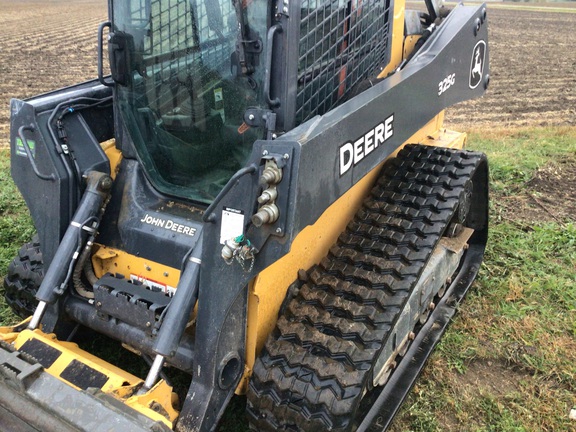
left=0, top=0, right=489, bottom=432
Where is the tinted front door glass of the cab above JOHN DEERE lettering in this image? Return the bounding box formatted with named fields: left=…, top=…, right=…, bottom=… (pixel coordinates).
left=114, top=0, right=267, bottom=202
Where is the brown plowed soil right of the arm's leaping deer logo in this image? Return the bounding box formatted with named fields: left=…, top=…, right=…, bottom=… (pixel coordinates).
left=446, top=3, right=576, bottom=130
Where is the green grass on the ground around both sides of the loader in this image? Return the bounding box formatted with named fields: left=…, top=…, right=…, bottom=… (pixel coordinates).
left=0, top=128, right=576, bottom=432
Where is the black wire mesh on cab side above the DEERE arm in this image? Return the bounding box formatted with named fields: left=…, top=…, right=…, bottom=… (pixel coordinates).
left=295, top=0, right=392, bottom=124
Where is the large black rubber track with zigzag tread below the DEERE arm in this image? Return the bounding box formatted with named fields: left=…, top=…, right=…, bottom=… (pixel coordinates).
left=247, top=145, right=485, bottom=432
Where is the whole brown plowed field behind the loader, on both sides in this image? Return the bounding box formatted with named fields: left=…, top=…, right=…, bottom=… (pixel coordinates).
left=0, top=0, right=576, bottom=146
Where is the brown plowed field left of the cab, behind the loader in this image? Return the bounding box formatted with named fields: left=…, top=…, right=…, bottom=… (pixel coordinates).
left=0, top=0, right=107, bottom=146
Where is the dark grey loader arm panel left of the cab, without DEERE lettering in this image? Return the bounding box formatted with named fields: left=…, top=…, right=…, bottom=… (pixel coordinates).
left=10, top=81, right=113, bottom=266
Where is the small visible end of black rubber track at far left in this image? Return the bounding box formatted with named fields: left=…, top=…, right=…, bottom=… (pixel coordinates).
left=4, top=236, right=44, bottom=318
